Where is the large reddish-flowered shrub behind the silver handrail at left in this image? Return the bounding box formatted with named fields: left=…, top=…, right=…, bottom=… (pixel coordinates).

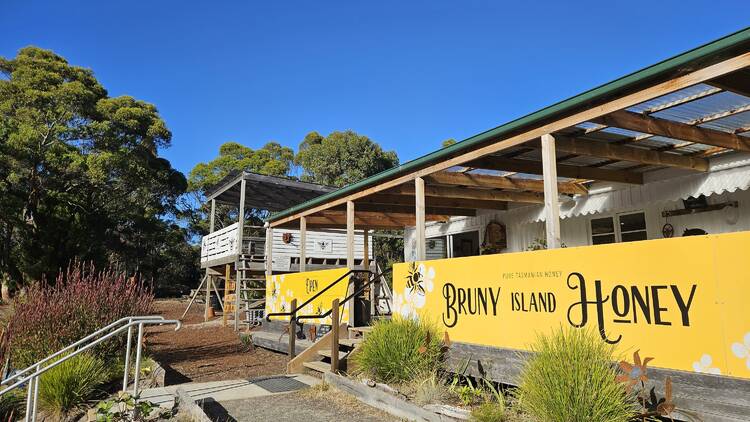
left=7, top=262, right=154, bottom=368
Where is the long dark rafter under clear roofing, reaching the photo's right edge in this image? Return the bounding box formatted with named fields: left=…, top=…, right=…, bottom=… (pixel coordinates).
left=594, top=110, right=750, bottom=151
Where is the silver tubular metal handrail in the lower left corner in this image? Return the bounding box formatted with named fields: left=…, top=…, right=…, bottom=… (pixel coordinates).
left=0, top=316, right=182, bottom=422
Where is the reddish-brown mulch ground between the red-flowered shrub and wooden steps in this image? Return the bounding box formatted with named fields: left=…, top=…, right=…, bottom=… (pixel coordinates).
left=146, top=299, right=288, bottom=385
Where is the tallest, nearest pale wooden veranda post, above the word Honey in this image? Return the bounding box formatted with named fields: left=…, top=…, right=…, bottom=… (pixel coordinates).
left=542, top=134, right=561, bottom=249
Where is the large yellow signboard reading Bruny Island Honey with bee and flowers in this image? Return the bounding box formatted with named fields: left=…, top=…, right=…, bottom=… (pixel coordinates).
left=393, top=232, right=750, bottom=379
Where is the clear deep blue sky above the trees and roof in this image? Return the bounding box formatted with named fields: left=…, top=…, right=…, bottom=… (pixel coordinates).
left=0, top=0, right=750, bottom=173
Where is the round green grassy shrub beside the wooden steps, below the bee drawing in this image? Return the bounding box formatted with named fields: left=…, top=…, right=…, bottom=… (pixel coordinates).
left=355, top=317, right=442, bottom=383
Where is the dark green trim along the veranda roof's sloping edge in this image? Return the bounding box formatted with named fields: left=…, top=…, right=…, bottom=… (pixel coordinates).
left=266, top=27, right=750, bottom=222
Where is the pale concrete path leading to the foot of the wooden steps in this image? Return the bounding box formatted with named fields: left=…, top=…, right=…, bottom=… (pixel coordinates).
left=141, top=374, right=321, bottom=408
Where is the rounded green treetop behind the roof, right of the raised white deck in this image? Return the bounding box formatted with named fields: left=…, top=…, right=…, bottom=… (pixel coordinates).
left=295, top=130, right=398, bottom=186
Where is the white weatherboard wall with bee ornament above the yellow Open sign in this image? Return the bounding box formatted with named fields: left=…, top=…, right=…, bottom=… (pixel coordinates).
left=273, top=228, right=372, bottom=260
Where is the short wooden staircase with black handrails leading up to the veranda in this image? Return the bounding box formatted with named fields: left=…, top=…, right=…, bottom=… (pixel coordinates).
left=294, top=324, right=372, bottom=374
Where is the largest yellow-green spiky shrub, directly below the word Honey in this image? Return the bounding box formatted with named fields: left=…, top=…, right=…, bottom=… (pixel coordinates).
left=516, top=329, right=635, bottom=422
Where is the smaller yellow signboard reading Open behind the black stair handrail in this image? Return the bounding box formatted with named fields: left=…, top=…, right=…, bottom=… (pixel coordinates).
left=266, top=268, right=349, bottom=324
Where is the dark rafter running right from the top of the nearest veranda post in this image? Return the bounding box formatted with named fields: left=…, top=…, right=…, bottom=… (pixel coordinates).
left=555, top=134, right=708, bottom=170
